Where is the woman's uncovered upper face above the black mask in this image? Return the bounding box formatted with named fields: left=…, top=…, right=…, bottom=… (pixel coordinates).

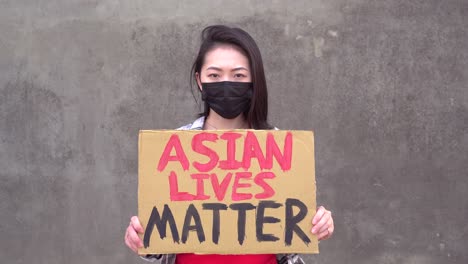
left=196, top=45, right=252, bottom=87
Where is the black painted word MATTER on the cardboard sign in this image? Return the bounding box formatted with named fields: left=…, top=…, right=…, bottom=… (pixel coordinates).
left=143, top=198, right=310, bottom=248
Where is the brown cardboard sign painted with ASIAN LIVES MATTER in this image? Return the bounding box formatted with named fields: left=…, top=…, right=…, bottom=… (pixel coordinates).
left=138, top=130, right=318, bottom=254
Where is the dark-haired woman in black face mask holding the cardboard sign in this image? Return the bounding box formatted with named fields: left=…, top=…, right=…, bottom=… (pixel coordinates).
left=125, top=26, right=334, bottom=264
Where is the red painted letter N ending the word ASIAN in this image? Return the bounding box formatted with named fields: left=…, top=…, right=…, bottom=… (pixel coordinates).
left=265, top=132, right=292, bottom=171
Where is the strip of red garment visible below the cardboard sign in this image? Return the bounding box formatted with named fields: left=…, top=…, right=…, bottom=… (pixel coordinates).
left=176, top=254, right=276, bottom=264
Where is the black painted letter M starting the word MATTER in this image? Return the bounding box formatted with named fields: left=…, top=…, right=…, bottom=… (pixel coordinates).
left=143, top=204, right=179, bottom=248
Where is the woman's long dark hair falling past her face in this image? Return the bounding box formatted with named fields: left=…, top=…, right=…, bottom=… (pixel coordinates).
left=190, top=25, right=272, bottom=129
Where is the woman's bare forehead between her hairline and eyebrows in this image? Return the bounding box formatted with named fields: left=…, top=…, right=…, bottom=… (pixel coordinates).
left=203, top=44, right=249, bottom=68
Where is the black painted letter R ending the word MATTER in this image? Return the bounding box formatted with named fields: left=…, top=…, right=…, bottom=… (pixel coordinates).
left=284, top=198, right=310, bottom=246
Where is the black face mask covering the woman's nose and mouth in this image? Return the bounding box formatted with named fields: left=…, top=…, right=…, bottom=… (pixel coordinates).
left=202, top=82, right=252, bottom=119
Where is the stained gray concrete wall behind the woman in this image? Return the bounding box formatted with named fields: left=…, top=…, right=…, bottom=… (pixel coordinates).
left=0, top=0, right=468, bottom=264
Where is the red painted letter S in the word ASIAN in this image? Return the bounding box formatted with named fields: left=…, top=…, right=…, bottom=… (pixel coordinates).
left=192, top=133, right=219, bottom=172
